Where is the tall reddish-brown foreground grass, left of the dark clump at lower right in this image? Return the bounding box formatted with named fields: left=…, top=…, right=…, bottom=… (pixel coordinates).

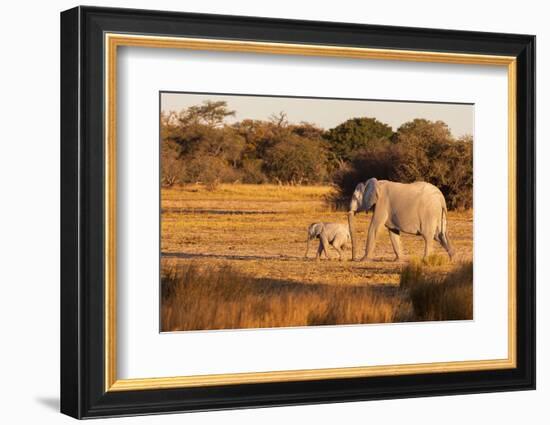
left=161, top=263, right=411, bottom=331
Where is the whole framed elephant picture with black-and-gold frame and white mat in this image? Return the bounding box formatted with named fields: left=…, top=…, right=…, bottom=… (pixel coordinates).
left=61, top=7, right=535, bottom=418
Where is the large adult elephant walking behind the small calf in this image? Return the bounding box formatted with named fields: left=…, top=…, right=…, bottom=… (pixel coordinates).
left=348, top=178, right=454, bottom=261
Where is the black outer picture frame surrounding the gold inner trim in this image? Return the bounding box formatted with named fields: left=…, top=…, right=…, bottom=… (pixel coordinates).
left=61, top=7, right=535, bottom=418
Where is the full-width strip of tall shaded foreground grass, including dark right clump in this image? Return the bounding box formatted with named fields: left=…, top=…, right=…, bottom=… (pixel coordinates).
left=161, top=263, right=473, bottom=331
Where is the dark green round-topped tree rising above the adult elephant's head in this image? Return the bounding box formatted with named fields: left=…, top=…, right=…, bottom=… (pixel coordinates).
left=325, top=118, right=393, bottom=162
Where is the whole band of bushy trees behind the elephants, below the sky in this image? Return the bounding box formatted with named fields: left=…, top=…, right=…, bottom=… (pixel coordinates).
left=161, top=101, right=473, bottom=209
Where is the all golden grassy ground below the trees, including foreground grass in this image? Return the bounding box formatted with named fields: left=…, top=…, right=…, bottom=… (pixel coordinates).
left=161, top=184, right=473, bottom=331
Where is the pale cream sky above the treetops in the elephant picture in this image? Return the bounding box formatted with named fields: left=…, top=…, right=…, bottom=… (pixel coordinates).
left=161, top=93, right=474, bottom=137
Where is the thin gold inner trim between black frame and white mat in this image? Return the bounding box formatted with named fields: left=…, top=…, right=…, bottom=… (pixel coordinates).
left=104, top=33, right=517, bottom=391
